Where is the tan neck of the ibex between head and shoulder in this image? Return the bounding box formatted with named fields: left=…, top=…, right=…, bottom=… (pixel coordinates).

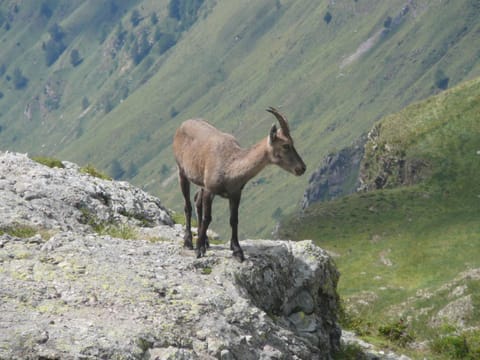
left=230, top=139, right=270, bottom=184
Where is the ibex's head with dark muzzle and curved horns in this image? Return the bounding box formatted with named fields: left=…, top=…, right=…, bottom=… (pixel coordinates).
left=267, top=107, right=307, bottom=176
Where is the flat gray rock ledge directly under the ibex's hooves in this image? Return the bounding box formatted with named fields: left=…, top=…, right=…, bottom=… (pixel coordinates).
left=0, top=232, right=340, bottom=359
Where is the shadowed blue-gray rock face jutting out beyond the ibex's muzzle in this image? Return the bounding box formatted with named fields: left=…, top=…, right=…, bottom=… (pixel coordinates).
left=302, top=138, right=366, bottom=209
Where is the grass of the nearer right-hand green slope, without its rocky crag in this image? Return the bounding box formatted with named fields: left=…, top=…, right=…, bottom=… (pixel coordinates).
left=280, top=78, right=480, bottom=358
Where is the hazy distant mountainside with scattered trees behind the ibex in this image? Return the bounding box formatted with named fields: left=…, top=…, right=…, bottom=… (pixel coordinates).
left=0, top=0, right=480, bottom=237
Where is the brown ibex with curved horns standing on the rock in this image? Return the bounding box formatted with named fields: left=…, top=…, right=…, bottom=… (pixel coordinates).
left=173, top=107, right=306, bottom=261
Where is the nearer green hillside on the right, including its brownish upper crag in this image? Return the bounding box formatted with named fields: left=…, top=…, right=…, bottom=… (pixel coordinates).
left=280, top=78, right=480, bottom=359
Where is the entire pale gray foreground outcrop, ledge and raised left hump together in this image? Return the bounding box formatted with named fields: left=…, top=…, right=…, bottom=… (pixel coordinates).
left=0, top=154, right=340, bottom=359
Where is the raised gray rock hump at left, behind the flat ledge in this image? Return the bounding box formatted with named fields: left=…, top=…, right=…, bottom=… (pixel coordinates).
left=0, top=152, right=173, bottom=232
